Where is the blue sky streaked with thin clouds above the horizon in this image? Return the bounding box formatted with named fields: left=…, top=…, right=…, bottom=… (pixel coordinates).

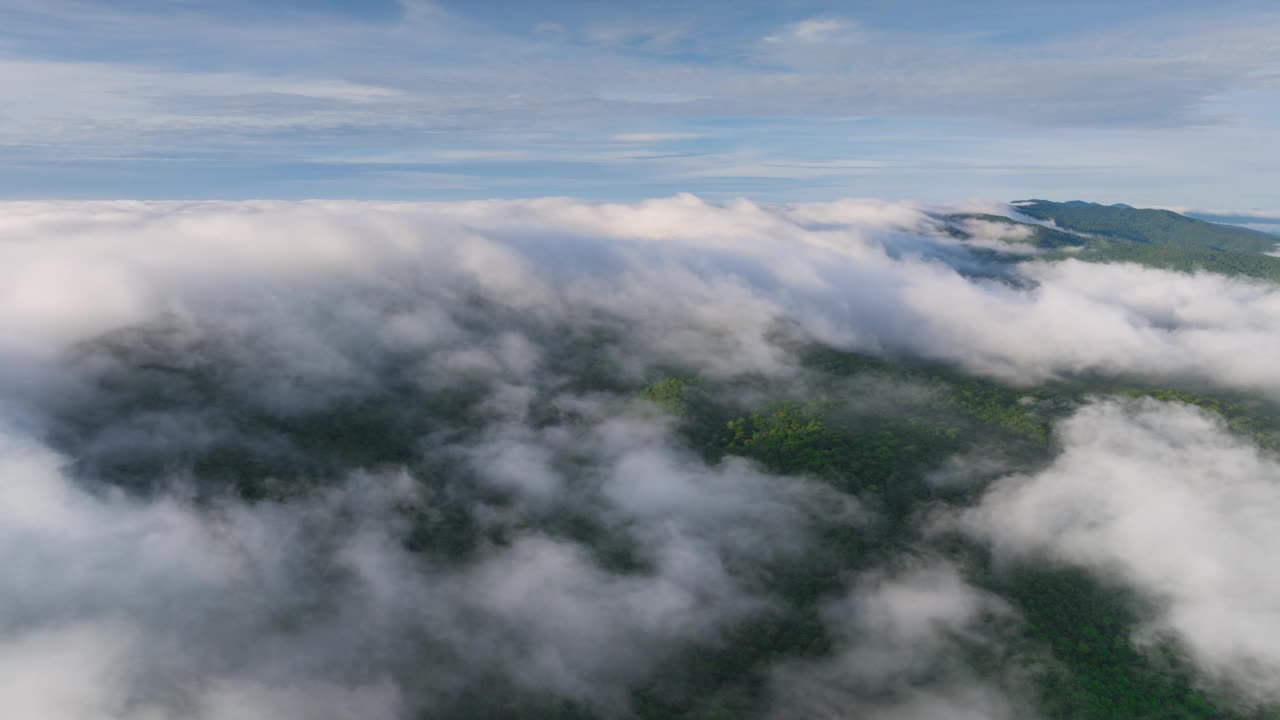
left=0, top=0, right=1280, bottom=211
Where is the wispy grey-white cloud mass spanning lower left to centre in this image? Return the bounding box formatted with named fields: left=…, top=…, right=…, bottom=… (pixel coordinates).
left=0, top=389, right=859, bottom=720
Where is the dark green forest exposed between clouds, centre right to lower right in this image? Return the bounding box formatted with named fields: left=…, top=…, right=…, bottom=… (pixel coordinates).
left=640, top=348, right=1280, bottom=720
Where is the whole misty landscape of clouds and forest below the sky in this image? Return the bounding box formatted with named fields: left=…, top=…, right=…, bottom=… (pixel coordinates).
left=0, top=195, right=1280, bottom=720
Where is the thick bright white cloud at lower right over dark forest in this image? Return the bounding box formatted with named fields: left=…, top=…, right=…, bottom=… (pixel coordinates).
left=963, top=401, right=1280, bottom=702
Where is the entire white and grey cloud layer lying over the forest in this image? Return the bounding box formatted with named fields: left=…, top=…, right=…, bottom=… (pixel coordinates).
left=0, top=196, right=1280, bottom=720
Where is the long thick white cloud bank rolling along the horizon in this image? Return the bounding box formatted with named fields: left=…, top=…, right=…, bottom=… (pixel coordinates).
left=0, top=196, right=1280, bottom=395
